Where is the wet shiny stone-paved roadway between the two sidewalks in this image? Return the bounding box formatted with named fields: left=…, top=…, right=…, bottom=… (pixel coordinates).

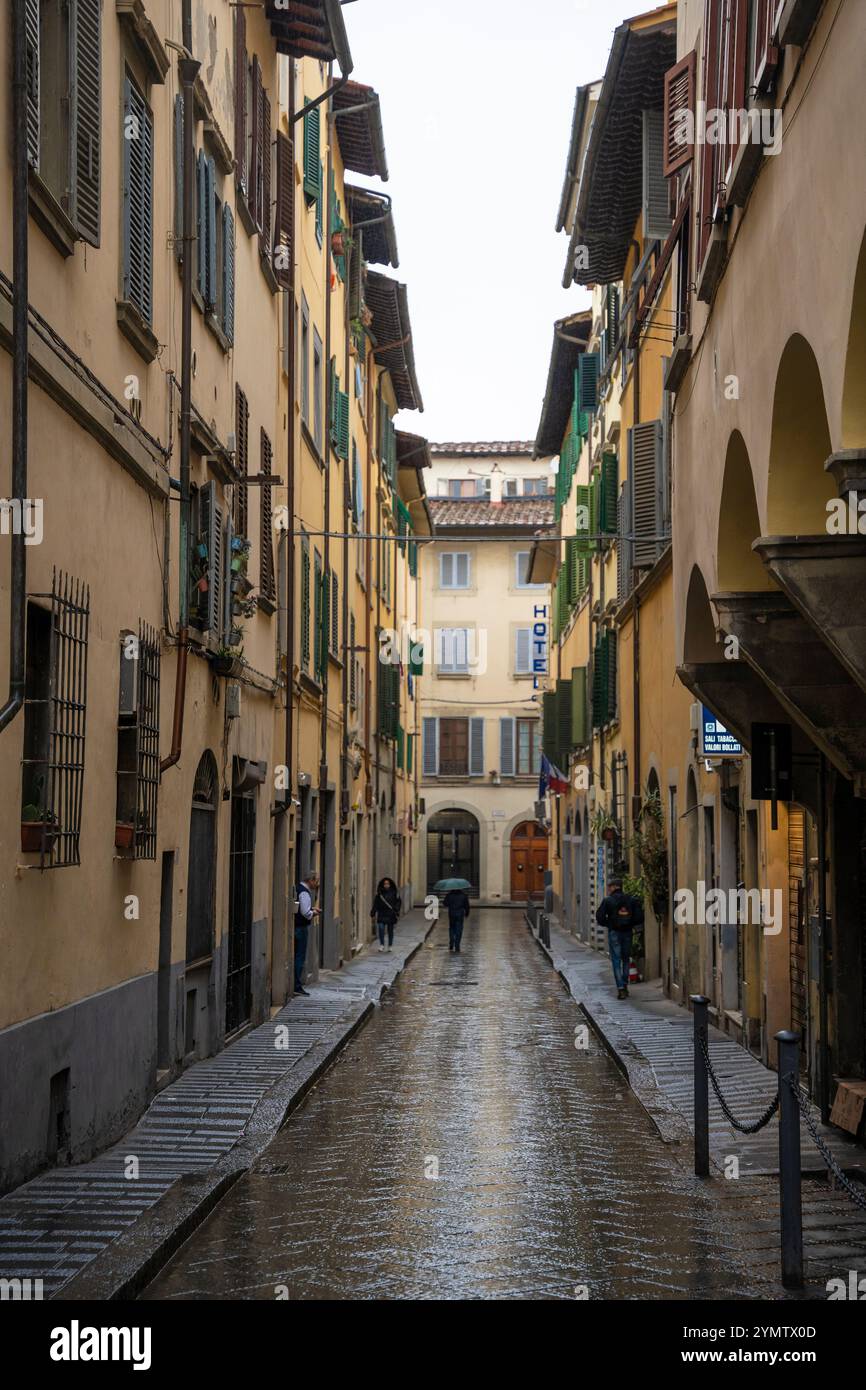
left=143, top=909, right=778, bottom=1300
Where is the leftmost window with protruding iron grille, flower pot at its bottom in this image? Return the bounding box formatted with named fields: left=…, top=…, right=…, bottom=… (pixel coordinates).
left=21, top=570, right=90, bottom=869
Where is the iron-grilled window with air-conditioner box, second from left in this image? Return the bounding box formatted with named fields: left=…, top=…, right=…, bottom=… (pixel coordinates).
left=114, top=623, right=161, bottom=859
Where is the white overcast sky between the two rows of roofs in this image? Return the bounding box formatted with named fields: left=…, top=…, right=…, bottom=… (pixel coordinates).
left=343, top=0, right=631, bottom=441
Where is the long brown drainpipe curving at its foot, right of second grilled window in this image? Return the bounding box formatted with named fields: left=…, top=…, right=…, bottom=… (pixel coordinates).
left=160, top=21, right=202, bottom=773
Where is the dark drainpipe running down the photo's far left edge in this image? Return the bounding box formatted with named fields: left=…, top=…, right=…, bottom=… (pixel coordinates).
left=0, top=4, right=29, bottom=731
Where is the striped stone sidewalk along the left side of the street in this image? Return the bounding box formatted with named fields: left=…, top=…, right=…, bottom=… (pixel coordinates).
left=0, top=909, right=434, bottom=1298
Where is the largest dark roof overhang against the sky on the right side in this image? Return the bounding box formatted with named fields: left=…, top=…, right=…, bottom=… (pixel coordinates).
left=563, top=7, right=677, bottom=286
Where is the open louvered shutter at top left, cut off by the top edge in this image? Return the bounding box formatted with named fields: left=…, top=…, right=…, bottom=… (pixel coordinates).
left=72, top=0, right=101, bottom=246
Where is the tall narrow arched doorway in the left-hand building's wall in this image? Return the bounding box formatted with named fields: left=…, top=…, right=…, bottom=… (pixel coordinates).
left=183, top=749, right=220, bottom=1059
